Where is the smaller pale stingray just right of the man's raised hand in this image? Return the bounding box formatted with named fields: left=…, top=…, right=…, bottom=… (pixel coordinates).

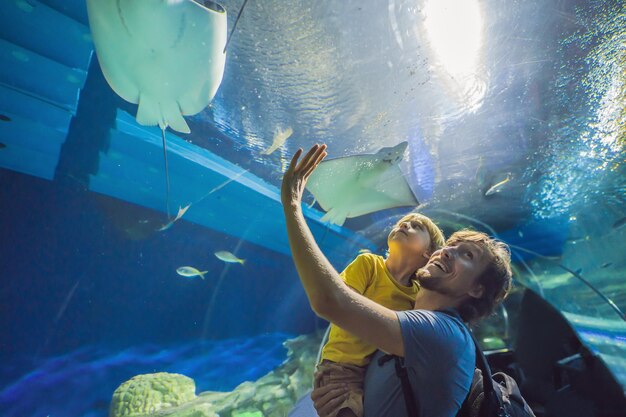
left=306, top=142, right=419, bottom=226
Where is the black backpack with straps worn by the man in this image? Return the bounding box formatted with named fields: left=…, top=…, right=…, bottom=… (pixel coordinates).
left=378, top=311, right=535, bottom=417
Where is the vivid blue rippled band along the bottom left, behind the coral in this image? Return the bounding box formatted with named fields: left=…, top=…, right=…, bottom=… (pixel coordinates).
left=0, top=333, right=290, bottom=417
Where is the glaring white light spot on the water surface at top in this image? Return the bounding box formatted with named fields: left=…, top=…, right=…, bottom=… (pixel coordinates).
left=423, top=0, right=483, bottom=84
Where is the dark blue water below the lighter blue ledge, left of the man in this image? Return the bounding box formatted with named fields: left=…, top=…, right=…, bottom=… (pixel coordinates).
left=0, top=170, right=323, bottom=417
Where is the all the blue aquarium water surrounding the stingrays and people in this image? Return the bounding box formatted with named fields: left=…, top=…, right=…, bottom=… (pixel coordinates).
left=0, top=0, right=626, bottom=417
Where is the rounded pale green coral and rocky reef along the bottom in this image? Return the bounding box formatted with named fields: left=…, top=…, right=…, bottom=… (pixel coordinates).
left=109, top=334, right=322, bottom=417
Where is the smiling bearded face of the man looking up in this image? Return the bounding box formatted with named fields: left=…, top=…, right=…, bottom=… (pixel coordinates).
left=417, top=242, right=489, bottom=298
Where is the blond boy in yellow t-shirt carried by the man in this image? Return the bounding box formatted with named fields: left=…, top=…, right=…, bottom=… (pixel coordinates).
left=313, top=213, right=444, bottom=417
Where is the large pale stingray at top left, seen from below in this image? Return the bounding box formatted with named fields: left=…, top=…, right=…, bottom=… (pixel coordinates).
left=87, top=0, right=227, bottom=133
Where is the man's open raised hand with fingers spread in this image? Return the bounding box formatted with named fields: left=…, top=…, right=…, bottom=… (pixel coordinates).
left=280, top=144, right=327, bottom=207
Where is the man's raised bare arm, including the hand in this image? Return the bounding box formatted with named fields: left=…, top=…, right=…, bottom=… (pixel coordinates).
left=281, top=145, right=404, bottom=356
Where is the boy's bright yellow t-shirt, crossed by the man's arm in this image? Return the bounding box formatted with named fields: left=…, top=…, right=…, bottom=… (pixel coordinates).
left=322, top=253, right=419, bottom=366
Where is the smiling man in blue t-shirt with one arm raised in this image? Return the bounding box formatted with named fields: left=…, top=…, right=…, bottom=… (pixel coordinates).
left=281, top=145, right=512, bottom=417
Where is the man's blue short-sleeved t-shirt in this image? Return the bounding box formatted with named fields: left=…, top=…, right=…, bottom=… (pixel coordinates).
left=364, top=310, right=476, bottom=417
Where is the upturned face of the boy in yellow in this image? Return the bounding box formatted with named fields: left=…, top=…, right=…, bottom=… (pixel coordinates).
left=387, top=219, right=430, bottom=260
